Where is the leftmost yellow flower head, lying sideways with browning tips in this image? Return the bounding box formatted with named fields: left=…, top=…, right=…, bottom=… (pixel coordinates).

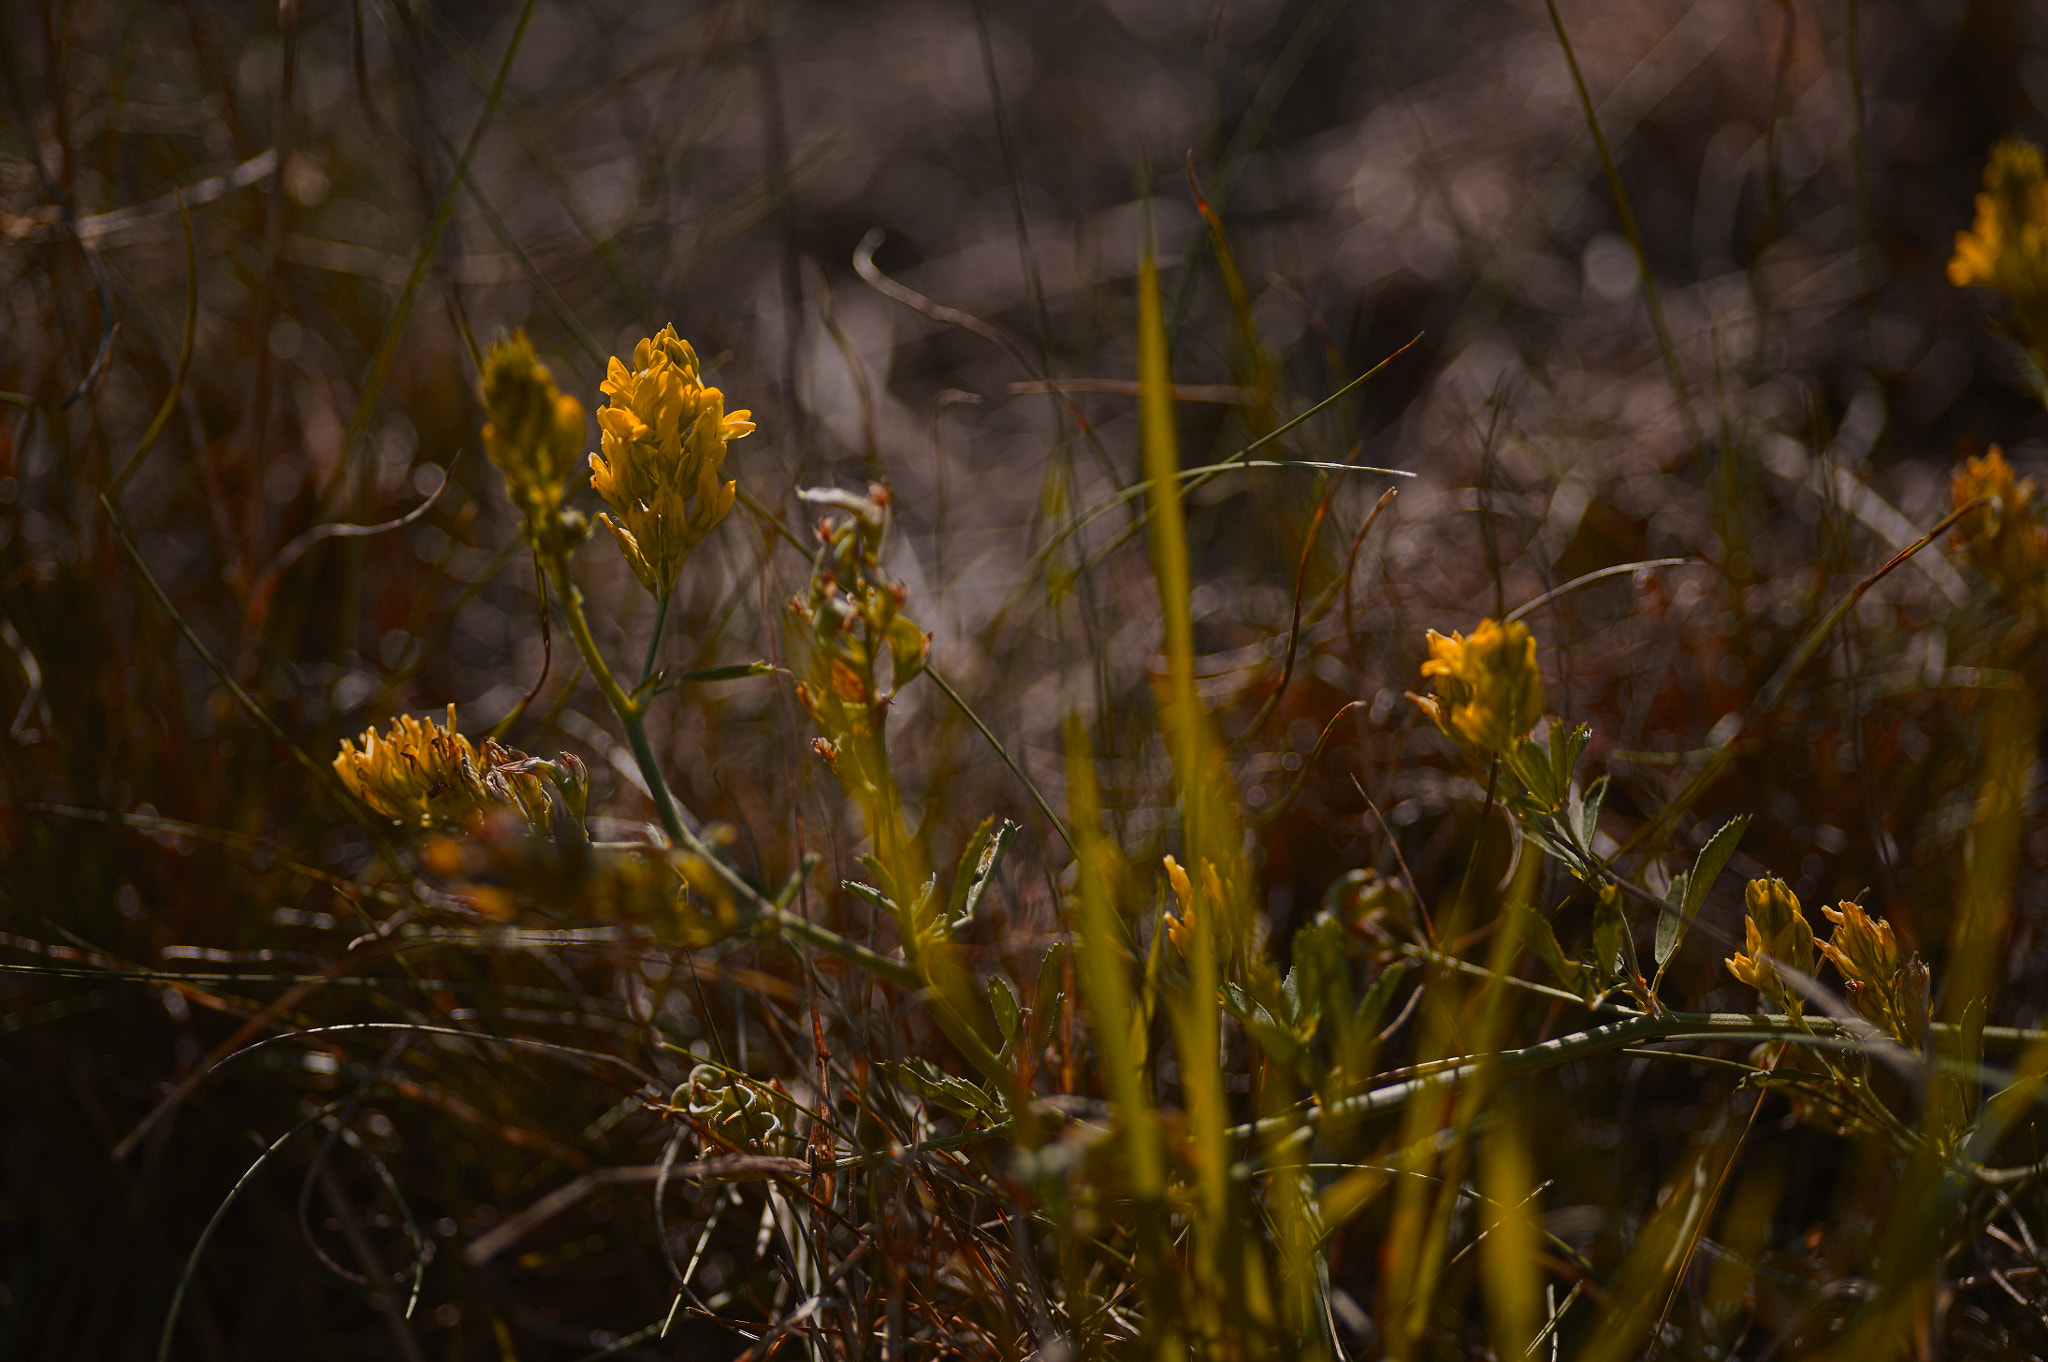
left=334, top=705, right=549, bottom=827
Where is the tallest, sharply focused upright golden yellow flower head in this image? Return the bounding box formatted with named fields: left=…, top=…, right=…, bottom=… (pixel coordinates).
left=590, top=326, right=754, bottom=596
